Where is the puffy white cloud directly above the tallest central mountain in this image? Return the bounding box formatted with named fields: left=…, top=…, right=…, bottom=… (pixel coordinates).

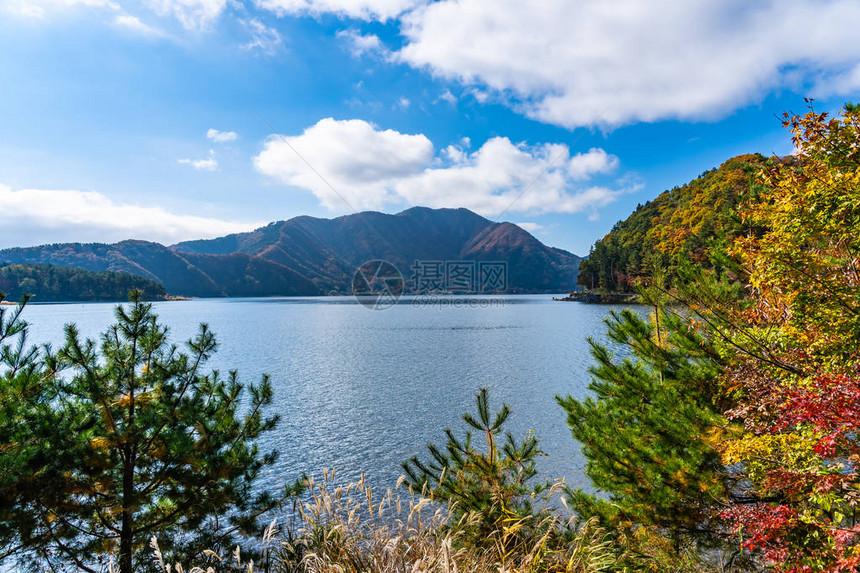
left=254, top=118, right=637, bottom=216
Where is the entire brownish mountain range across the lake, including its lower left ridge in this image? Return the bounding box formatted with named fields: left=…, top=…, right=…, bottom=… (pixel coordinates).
left=0, top=207, right=580, bottom=297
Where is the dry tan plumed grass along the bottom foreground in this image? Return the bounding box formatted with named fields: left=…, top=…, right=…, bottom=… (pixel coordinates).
left=148, top=472, right=618, bottom=573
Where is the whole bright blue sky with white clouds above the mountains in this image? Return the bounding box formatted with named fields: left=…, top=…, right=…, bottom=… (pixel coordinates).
left=0, top=0, right=860, bottom=255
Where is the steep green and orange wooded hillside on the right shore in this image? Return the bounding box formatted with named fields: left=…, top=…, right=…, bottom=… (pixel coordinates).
left=578, top=154, right=767, bottom=292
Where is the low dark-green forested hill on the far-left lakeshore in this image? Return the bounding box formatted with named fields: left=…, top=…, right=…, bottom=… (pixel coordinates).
left=0, top=264, right=167, bottom=302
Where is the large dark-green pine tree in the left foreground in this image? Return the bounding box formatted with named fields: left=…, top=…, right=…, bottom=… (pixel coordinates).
left=0, top=295, right=289, bottom=573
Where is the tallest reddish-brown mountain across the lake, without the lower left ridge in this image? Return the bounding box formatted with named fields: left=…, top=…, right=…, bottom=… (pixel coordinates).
left=171, top=207, right=580, bottom=292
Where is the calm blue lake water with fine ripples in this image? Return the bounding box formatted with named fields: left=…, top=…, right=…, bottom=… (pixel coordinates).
left=18, top=295, right=632, bottom=489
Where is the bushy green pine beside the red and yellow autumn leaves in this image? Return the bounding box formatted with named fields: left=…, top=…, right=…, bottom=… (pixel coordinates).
left=556, top=289, right=728, bottom=540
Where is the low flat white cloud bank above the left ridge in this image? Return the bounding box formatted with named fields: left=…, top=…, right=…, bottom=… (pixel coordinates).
left=0, top=185, right=258, bottom=247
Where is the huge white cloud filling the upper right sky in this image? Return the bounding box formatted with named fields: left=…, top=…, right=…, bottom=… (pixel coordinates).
left=397, top=0, right=860, bottom=128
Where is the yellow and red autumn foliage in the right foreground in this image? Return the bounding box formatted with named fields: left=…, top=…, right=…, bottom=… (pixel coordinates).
left=721, top=104, right=860, bottom=572
